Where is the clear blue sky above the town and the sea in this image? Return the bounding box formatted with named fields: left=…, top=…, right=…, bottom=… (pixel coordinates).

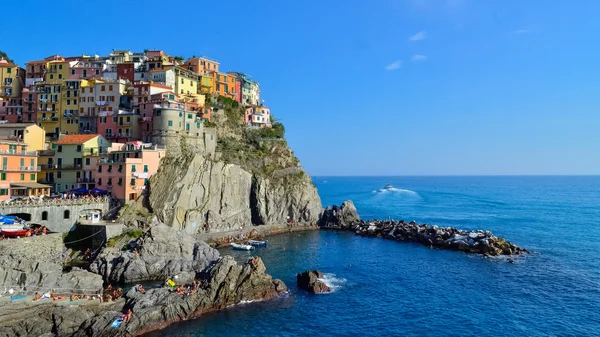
left=0, top=0, right=600, bottom=175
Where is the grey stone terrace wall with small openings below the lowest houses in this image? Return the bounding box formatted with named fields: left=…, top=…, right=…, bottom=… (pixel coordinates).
left=0, top=199, right=109, bottom=233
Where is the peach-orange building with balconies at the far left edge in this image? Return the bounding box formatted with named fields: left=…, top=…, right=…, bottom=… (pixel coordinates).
left=0, top=140, right=50, bottom=200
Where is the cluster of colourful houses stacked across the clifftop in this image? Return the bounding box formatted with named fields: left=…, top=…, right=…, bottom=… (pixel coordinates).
left=0, top=50, right=271, bottom=201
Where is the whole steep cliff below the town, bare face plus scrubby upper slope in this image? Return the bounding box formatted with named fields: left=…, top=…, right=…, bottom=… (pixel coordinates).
left=126, top=96, right=322, bottom=233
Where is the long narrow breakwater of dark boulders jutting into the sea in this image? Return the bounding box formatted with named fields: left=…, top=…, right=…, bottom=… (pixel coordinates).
left=319, top=201, right=529, bottom=256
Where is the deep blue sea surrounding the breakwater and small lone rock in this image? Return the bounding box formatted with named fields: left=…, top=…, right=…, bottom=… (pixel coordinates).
left=151, top=177, right=600, bottom=337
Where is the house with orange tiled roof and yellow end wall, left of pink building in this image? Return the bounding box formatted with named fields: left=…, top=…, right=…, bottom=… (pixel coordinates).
left=51, top=134, right=110, bottom=192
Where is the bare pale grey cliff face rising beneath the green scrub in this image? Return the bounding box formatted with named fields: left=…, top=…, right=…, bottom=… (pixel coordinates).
left=149, top=150, right=322, bottom=233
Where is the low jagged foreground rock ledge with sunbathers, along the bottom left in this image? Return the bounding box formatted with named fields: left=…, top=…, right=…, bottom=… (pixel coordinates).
left=0, top=256, right=287, bottom=337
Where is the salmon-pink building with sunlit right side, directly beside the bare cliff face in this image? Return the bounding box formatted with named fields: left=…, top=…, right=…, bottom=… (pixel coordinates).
left=96, top=142, right=166, bottom=201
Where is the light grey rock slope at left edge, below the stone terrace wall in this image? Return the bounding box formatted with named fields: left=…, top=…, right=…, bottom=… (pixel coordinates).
left=0, top=234, right=102, bottom=294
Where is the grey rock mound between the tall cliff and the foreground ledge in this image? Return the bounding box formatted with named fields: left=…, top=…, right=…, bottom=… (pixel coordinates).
left=90, top=224, right=219, bottom=283
